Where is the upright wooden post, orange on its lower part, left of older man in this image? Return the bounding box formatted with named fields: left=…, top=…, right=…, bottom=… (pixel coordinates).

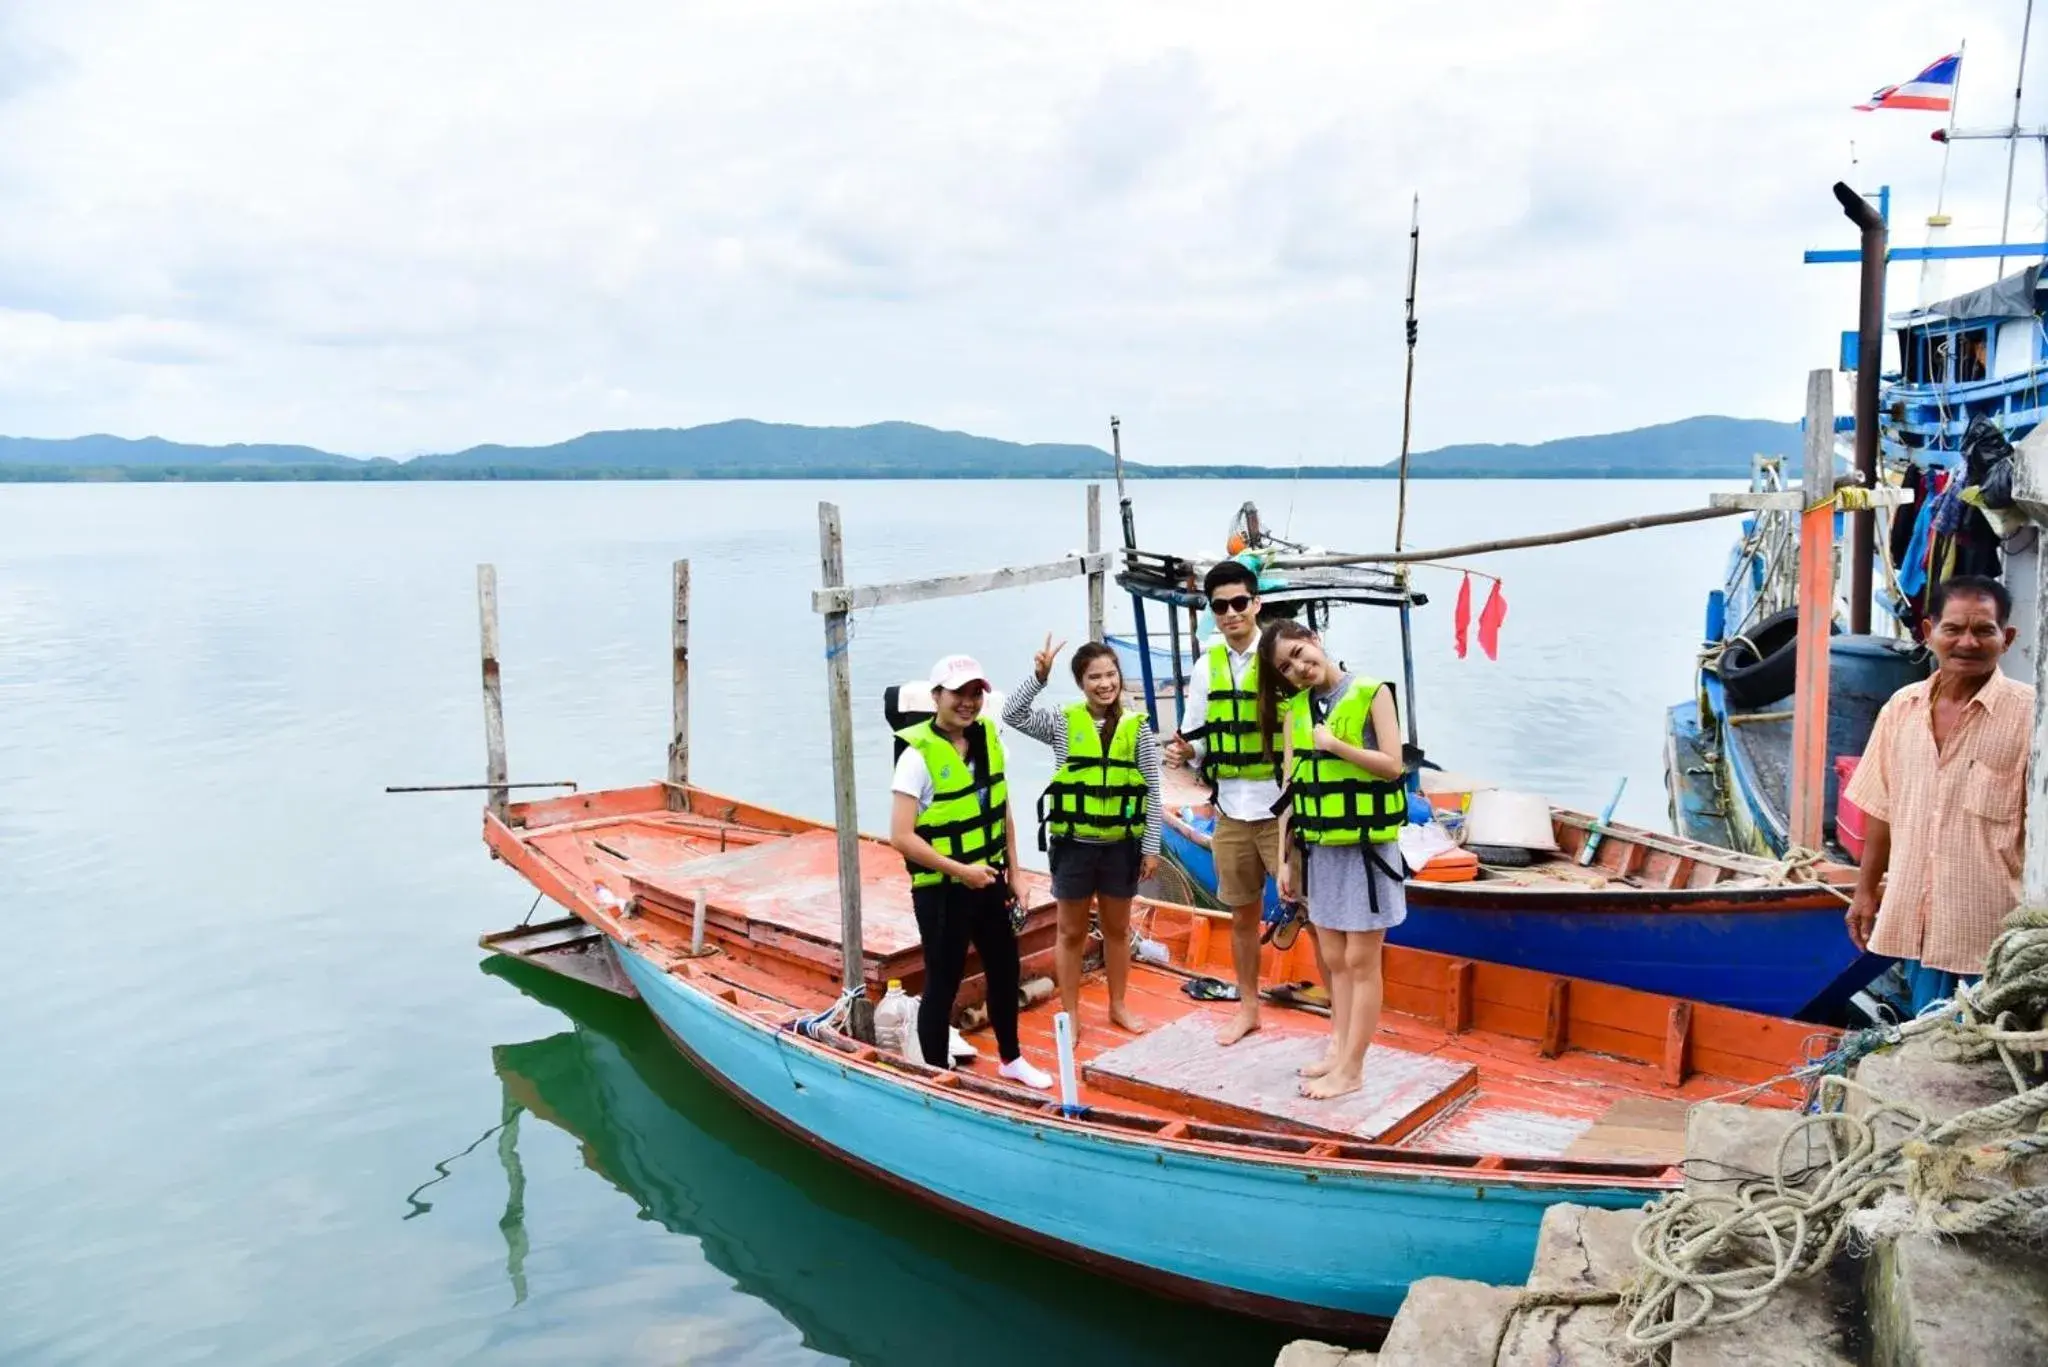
left=1790, top=371, right=1835, bottom=851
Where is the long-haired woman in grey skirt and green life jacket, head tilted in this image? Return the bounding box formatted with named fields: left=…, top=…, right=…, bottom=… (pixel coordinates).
left=1260, top=621, right=1407, bottom=1099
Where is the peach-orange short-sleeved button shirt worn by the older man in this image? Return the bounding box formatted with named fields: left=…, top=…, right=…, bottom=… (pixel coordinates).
left=1845, top=674, right=2034, bottom=976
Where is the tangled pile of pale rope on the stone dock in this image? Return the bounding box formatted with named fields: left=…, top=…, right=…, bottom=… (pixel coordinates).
left=1620, top=908, right=2048, bottom=1357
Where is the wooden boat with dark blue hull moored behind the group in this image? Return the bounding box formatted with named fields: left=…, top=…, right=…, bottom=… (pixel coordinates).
left=1163, top=769, right=1884, bottom=1021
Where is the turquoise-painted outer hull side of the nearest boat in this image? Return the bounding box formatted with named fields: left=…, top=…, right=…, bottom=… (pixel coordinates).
left=618, top=947, right=1657, bottom=1332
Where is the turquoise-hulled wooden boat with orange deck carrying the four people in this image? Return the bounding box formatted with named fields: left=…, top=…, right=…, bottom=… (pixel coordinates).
left=483, top=783, right=1833, bottom=1332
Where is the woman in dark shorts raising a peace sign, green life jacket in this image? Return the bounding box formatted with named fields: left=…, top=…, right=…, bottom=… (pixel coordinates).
left=1004, top=633, right=1159, bottom=1039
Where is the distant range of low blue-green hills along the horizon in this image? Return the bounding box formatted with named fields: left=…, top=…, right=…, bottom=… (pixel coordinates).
left=0, top=418, right=1798, bottom=482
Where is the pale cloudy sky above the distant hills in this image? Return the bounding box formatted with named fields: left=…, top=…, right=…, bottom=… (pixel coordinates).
left=0, top=0, right=2048, bottom=465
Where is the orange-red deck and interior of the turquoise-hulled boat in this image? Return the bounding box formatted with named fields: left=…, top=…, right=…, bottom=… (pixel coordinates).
left=485, top=785, right=1833, bottom=1183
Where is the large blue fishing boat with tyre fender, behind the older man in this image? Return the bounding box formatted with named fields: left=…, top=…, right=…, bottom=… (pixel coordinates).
left=1665, top=49, right=2048, bottom=893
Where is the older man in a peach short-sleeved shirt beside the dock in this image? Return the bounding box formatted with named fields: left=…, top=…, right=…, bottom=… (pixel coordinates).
left=1845, top=576, right=2034, bottom=1010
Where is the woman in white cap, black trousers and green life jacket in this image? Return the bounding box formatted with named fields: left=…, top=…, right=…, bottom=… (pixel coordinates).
left=889, top=656, right=1053, bottom=1090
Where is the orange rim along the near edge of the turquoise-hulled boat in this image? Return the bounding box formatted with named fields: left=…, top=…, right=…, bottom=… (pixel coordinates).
left=483, top=783, right=1843, bottom=1193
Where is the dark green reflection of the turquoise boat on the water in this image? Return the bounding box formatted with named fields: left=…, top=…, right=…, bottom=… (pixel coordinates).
left=483, top=959, right=1315, bottom=1367
